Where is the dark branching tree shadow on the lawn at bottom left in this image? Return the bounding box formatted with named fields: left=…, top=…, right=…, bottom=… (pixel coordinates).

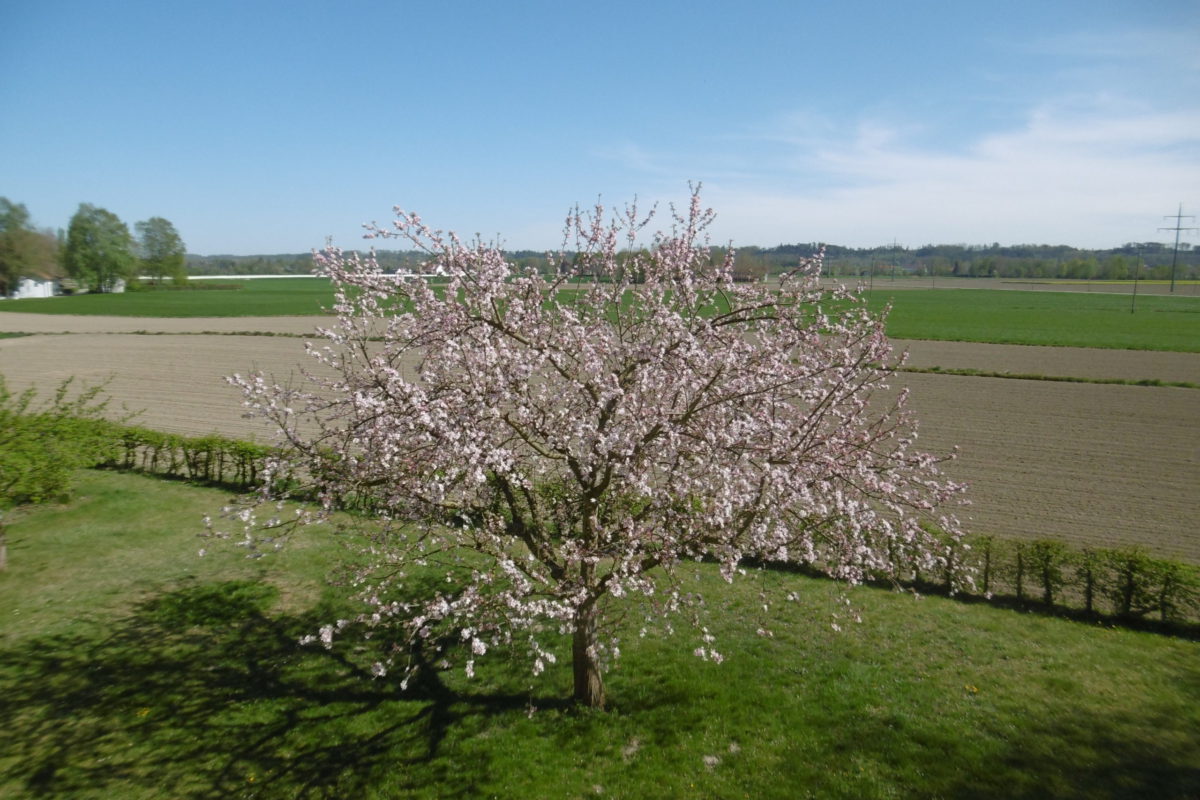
left=0, top=582, right=562, bottom=798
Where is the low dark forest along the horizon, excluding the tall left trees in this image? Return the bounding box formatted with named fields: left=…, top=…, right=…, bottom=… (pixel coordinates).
left=187, top=242, right=1200, bottom=281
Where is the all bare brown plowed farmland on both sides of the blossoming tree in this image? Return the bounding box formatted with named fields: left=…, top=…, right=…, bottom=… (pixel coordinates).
left=0, top=313, right=1200, bottom=563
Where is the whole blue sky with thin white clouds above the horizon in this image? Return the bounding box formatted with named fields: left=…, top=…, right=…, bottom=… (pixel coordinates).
left=0, top=0, right=1200, bottom=254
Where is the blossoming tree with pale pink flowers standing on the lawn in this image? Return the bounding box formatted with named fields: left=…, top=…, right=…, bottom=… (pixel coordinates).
left=218, top=192, right=962, bottom=706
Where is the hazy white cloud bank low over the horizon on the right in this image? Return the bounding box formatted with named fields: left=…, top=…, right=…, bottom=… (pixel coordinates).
left=604, top=96, right=1200, bottom=247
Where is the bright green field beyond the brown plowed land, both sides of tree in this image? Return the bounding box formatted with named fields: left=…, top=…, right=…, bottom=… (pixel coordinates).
left=0, top=278, right=1200, bottom=353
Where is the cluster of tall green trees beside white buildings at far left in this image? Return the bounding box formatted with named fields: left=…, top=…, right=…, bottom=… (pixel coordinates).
left=0, top=198, right=187, bottom=297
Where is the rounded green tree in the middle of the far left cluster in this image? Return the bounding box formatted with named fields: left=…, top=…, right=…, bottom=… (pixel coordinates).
left=62, top=203, right=138, bottom=291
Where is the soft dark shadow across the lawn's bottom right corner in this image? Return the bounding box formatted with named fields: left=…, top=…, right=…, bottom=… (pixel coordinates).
left=804, top=664, right=1200, bottom=800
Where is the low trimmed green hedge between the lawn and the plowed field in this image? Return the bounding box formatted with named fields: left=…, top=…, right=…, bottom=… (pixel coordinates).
left=0, top=398, right=1200, bottom=625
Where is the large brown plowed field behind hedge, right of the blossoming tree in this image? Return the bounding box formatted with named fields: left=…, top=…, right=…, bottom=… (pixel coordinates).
left=898, top=374, right=1200, bottom=561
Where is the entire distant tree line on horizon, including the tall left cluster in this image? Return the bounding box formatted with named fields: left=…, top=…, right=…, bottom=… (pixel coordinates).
left=0, top=198, right=1200, bottom=286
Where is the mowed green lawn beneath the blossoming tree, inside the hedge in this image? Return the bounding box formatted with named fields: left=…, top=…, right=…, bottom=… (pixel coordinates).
left=0, top=473, right=1200, bottom=799
